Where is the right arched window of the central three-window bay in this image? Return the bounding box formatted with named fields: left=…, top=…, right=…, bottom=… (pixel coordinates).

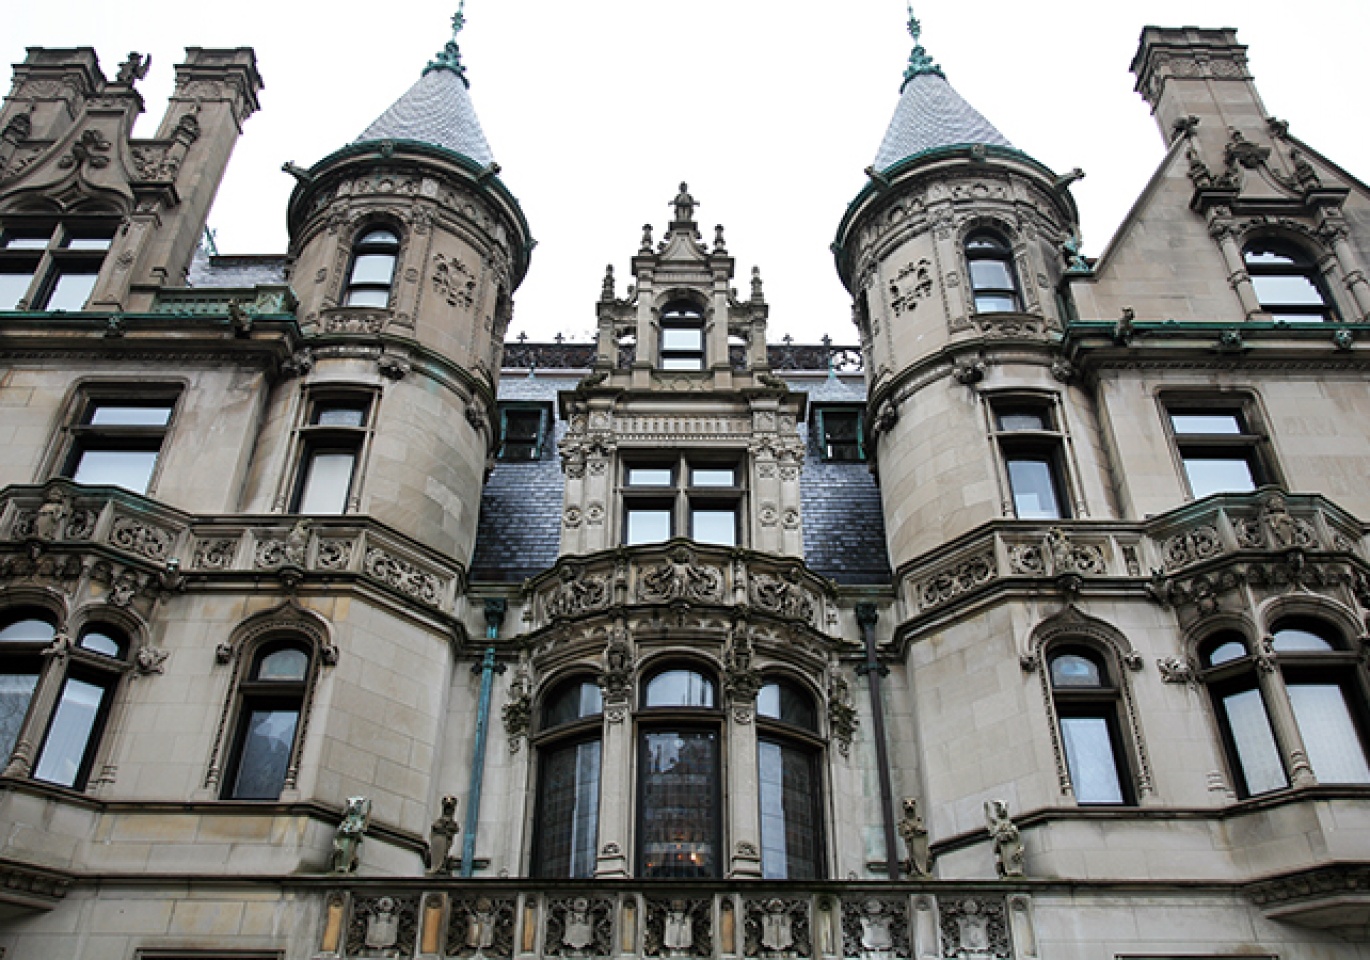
left=756, top=679, right=823, bottom=881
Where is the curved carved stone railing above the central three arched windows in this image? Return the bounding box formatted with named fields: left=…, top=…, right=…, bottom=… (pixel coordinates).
left=526, top=540, right=837, bottom=633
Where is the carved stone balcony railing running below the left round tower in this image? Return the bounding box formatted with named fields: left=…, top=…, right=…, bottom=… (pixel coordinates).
left=0, top=481, right=466, bottom=612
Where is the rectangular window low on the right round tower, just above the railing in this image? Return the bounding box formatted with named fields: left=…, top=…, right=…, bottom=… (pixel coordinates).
left=992, top=400, right=1070, bottom=520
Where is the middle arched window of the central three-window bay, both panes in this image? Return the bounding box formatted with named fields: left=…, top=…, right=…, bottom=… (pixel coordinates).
left=637, top=667, right=722, bottom=879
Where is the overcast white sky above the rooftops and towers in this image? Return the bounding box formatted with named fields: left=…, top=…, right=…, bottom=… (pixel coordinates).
left=0, top=0, right=1370, bottom=342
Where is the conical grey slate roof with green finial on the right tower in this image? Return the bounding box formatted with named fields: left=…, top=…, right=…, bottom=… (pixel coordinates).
left=874, top=7, right=1012, bottom=173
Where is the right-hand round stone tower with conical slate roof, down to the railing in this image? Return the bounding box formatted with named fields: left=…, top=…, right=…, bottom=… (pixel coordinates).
left=833, top=14, right=1103, bottom=570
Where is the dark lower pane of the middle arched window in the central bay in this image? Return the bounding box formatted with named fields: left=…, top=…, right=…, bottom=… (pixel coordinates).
left=638, top=730, right=721, bottom=879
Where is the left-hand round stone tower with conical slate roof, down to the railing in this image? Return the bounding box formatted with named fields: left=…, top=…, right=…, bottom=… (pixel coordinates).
left=257, top=12, right=533, bottom=560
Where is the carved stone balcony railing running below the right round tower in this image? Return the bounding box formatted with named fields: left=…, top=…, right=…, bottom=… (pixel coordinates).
left=899, top=488, right=1365, bottom=618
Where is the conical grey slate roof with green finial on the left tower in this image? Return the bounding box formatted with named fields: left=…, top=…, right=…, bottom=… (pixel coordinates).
left=358, top=0, right=493, bottom=167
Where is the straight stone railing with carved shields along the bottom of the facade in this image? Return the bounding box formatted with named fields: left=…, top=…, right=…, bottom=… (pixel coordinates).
left=314, top=876, right=1037, bottom=960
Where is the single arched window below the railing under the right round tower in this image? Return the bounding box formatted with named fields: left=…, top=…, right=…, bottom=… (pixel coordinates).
left=1048, top=645, right=1134, bottom=804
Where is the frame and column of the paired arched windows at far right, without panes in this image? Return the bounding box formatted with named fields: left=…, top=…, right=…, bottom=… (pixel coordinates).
left=1189, top=597, right=1370, bottom=800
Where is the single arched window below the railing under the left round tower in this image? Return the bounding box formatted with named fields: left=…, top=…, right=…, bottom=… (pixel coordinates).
left=223, top=640, right=311, bottom=800
